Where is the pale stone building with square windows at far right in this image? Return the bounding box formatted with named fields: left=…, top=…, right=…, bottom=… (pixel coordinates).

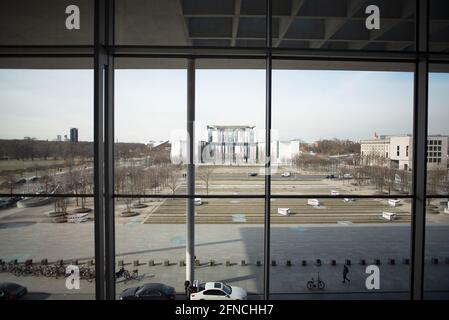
left=360, top=135, right=448, bottom=170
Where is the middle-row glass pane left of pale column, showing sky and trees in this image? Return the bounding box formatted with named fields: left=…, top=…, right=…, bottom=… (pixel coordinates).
left=115, top=59, right=187, bottom=195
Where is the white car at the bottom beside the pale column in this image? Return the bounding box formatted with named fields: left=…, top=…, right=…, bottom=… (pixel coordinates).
left=190, top=282, right=248, bottom=300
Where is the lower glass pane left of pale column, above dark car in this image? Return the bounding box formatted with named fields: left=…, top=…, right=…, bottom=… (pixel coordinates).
left=115, top=198, right=186, bottom=297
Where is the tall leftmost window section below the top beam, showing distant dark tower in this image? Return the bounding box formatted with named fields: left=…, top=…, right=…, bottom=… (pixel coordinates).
left=0, top=59, right=95, bottom=299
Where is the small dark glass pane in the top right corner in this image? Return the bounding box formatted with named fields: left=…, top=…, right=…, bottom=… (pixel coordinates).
left=429, top=0, right=449, bottom=52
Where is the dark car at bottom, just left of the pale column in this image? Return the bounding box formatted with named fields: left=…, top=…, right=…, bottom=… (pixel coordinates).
left=119, top=283, right=176, bottom=300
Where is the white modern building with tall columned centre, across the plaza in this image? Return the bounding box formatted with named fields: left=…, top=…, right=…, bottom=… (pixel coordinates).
left=171, top=125, right=301, bottom=165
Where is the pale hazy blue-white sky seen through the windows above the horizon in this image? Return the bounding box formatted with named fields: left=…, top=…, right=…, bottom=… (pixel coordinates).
left=0, top=69, right=449, bottom=143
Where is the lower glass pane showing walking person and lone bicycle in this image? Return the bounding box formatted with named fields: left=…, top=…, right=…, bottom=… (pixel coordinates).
left=270, top=198, right=411, bottom=299
